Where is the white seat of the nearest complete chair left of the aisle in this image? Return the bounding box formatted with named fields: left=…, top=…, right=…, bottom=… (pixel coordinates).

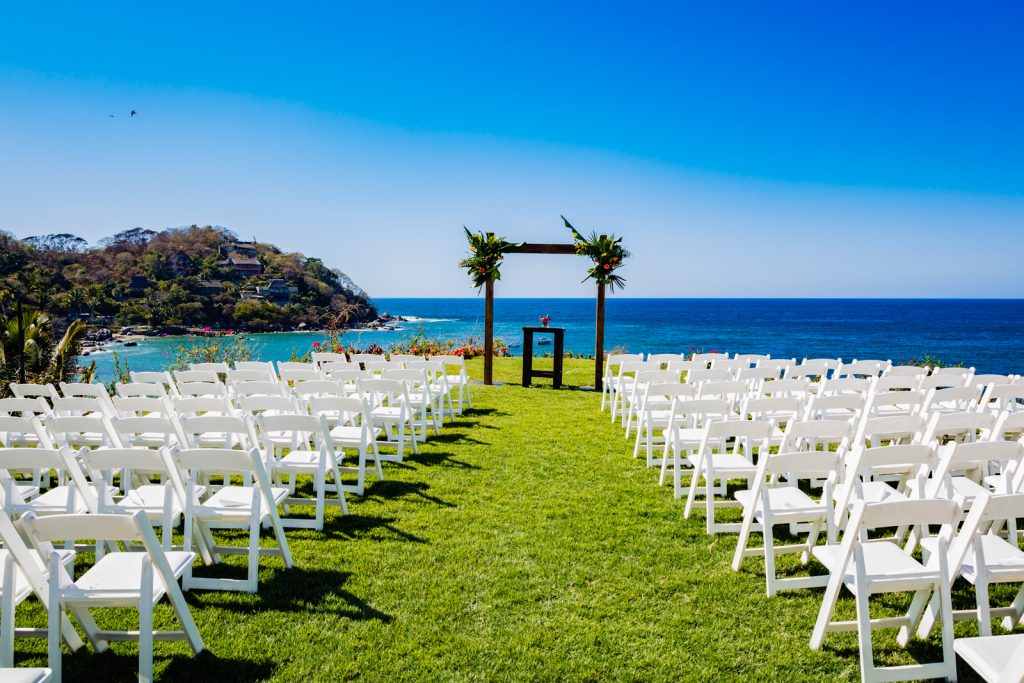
left=63, top=551, right=196, bottom=604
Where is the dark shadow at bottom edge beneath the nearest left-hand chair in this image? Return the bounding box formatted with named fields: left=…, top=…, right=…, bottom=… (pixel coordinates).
left=62, top=643, right=276, bottom=683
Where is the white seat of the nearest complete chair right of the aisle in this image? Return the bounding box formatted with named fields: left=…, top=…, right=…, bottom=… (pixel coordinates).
left=812, top=541, right=939, bottom=593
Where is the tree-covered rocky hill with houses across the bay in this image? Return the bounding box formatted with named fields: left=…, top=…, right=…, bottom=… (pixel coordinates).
left=0, top=225, right=377, bottom=331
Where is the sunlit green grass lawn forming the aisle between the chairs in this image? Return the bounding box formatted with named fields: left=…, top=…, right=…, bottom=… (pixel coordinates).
left=15, top=358, right=1007, bottom=681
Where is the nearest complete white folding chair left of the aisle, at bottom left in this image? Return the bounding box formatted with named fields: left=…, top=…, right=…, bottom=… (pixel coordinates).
left=22, top=512, right=204, bottom=682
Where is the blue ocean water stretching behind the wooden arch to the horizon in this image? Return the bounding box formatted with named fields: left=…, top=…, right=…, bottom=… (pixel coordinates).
left=83, top=297, right=1024, bottom=380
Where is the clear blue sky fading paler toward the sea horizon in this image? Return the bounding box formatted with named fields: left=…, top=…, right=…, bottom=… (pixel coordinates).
left=0, top=0, right=1024, bottom=297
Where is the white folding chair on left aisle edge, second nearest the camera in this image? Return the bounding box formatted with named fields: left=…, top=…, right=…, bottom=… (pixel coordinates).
left=165, top=449, right=292, bottom=593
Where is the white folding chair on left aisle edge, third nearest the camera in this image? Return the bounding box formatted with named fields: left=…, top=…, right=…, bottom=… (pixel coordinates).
left=256, top=414, right=348, bottom=530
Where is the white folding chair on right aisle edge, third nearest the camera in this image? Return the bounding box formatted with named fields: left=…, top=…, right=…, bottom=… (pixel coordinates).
left=683, top=420, right=775, bottom=535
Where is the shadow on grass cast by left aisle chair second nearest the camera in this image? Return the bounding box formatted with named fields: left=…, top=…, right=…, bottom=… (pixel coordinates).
left=188, top=566, right=394, bottom=624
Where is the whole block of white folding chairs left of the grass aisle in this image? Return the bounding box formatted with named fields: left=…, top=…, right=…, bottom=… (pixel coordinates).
left=0, top=358, right=468, bottom=680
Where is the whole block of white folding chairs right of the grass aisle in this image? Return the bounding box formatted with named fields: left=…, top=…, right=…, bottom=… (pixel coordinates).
left=609, top=358, right=1024, bottom=681
